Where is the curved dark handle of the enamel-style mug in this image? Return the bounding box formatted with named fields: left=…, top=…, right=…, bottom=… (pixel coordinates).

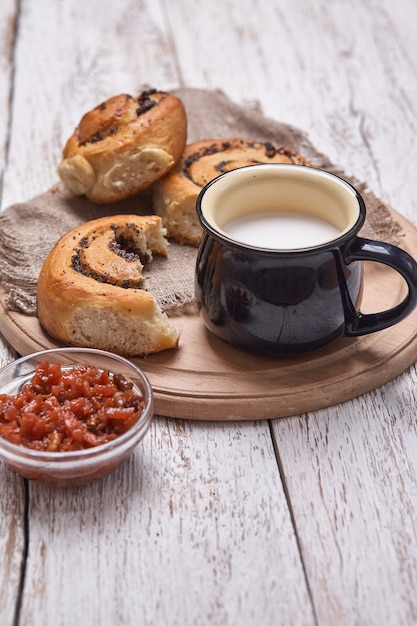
left=344, top=237, right=417, bottom=337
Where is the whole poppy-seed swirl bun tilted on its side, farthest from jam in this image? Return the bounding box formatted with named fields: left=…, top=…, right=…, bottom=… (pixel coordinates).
left=58, top=90, right=187, bottom=203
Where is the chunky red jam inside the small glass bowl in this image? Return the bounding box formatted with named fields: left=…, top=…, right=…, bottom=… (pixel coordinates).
left=0, top=361, right=144, bottom=452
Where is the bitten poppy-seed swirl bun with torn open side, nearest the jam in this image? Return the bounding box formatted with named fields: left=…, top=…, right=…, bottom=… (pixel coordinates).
left=37, top=215, right=179, bottom=357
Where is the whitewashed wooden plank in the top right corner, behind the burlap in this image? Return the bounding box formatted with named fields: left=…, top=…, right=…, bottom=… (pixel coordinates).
left=167, top=0, right=417, bottom=217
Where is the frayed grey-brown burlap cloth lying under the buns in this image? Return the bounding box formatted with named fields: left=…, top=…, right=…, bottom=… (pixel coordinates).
left=0, top=89, right=401, bottom=316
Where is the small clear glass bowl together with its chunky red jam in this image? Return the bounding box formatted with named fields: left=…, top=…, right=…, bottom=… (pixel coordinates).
left=0, top=348, right=153, bottom=486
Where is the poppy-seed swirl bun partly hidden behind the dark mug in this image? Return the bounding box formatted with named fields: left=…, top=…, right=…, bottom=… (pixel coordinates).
left=152, top=139, right=309, bottom=247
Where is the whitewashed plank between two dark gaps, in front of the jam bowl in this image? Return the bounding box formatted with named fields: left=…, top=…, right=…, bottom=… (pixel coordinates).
left=22, top=419, right=314, bottom=626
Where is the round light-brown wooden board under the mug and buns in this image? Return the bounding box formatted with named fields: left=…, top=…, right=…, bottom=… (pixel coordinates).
left=0, top=206, right=417, bottom=421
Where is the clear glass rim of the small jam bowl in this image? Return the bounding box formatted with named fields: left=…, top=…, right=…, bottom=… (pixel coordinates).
left=0, top=346, right=153, bottom=462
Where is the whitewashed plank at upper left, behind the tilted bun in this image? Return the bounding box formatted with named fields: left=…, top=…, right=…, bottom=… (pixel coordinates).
left=3, top=0, right=179, bottom=207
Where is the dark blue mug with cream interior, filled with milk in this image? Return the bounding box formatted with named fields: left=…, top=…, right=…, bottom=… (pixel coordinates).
left=196, top=164, right=417, bottom=355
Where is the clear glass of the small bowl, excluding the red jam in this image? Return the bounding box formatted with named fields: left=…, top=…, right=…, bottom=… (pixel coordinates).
left=0, top=348, right=153, bottom=486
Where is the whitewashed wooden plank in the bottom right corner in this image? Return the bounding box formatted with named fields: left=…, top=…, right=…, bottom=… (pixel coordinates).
left=273, top=390, right=417, bottom=626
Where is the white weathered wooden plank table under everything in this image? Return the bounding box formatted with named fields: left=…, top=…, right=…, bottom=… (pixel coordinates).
left=0, top=0, right=417, bottom=626
